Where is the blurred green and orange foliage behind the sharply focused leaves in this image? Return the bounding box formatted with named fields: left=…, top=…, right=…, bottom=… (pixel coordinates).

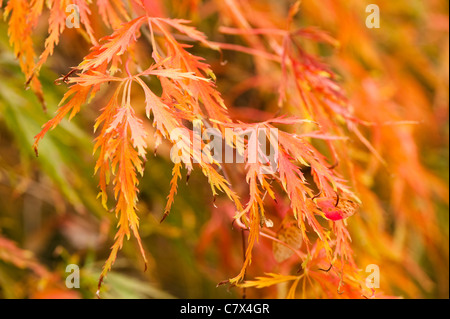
left=0, top=0, right=449, bottom=298
